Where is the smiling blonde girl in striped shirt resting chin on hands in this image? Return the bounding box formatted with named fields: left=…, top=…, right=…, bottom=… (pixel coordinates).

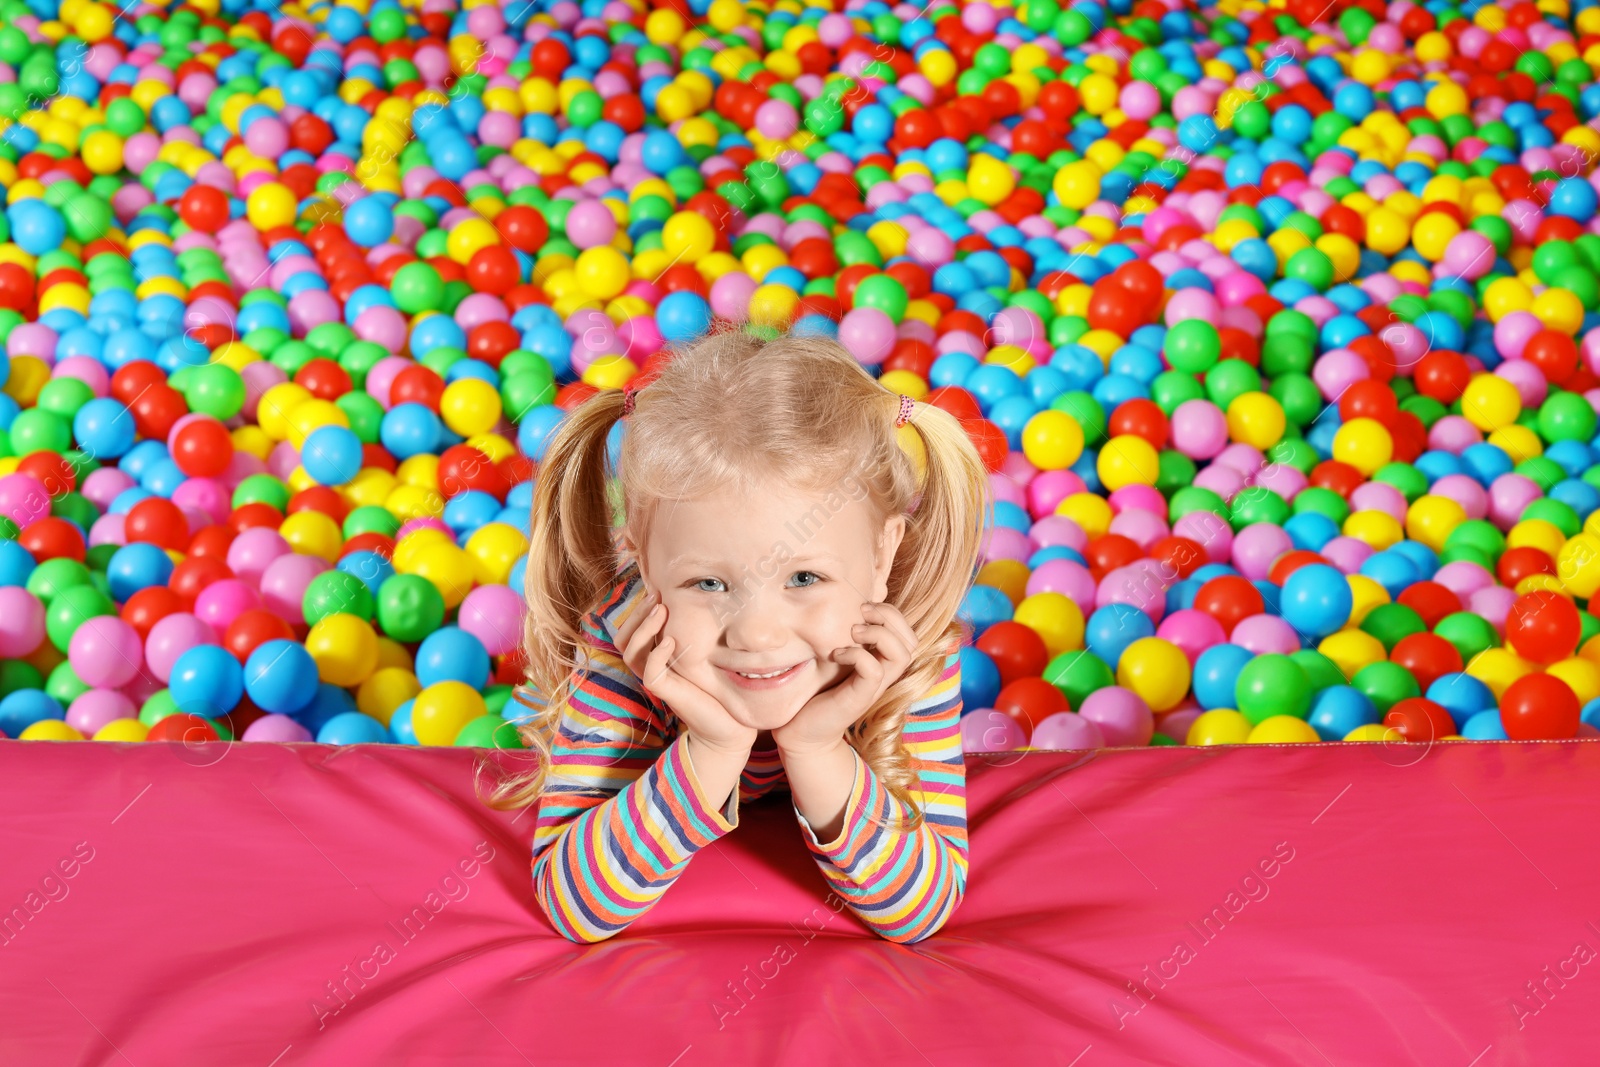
left=491, top=331, right=990, bottom=942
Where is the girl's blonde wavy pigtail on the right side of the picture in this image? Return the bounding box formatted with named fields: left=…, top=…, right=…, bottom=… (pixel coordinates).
left=846, top=395, right=992, bottom=832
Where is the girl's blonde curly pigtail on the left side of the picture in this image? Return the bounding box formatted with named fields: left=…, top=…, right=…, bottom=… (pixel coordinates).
left=483, top=389, right=624, bottom=811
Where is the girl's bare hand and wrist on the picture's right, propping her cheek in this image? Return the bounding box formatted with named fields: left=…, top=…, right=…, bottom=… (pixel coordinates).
left=773, top=603, right=917, bottom=753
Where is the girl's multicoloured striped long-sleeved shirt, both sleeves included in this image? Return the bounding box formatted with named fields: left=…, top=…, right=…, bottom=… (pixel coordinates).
left=517, top=565, right=966, bottom=942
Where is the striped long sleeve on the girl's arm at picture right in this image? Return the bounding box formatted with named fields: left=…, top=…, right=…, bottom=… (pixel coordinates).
left=794, top=653, right=966, bottom=942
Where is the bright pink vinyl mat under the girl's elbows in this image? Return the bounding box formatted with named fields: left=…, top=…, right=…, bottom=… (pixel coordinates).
left=0, top=741, right=1600, bottom=1067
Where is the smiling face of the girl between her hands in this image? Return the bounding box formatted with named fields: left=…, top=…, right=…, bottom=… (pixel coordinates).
left=638, top=486, right=906, bottom=731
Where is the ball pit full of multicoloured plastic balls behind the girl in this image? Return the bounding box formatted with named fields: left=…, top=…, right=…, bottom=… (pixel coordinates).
left=0, top=0, right=1600, bottom=750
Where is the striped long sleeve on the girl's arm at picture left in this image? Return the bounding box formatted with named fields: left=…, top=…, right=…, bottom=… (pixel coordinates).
left=533, top=587, right=739, bottom=942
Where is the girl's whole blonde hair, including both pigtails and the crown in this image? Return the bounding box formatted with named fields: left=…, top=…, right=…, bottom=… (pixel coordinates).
left=485, top=330, right=990, bottom=829
